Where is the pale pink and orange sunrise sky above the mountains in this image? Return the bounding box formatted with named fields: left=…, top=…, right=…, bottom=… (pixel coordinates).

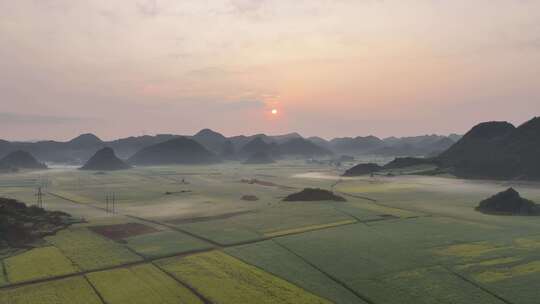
left=0, top=0, right=540, bottom=140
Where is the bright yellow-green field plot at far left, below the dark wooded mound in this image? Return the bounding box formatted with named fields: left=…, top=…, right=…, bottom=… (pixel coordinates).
left=4, top=246, right=78, bottom=283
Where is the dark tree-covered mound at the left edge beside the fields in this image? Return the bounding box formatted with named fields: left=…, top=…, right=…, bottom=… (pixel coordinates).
left=0, top=198, right=75, bottom=249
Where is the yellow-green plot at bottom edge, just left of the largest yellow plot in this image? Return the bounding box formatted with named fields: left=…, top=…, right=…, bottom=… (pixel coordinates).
left=87, top=264, right=202, bottom=304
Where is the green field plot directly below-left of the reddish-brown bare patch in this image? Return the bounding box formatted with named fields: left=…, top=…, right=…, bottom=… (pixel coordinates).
left=47, top=228, right=142, bottom=270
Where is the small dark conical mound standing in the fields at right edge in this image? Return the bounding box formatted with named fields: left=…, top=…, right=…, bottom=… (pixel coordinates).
left=476, top=188, right=540, bottom=215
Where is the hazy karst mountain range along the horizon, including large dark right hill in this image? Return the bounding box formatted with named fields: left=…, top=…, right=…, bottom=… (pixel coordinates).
left=0, top=117, right=540, bottom=180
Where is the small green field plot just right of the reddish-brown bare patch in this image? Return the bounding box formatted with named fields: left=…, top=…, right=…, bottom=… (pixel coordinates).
left=126, top=231, right=211, bottom=258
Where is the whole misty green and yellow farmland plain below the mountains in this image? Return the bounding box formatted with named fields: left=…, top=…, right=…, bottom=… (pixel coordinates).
left=0, top=161, right=540, bottom=304
